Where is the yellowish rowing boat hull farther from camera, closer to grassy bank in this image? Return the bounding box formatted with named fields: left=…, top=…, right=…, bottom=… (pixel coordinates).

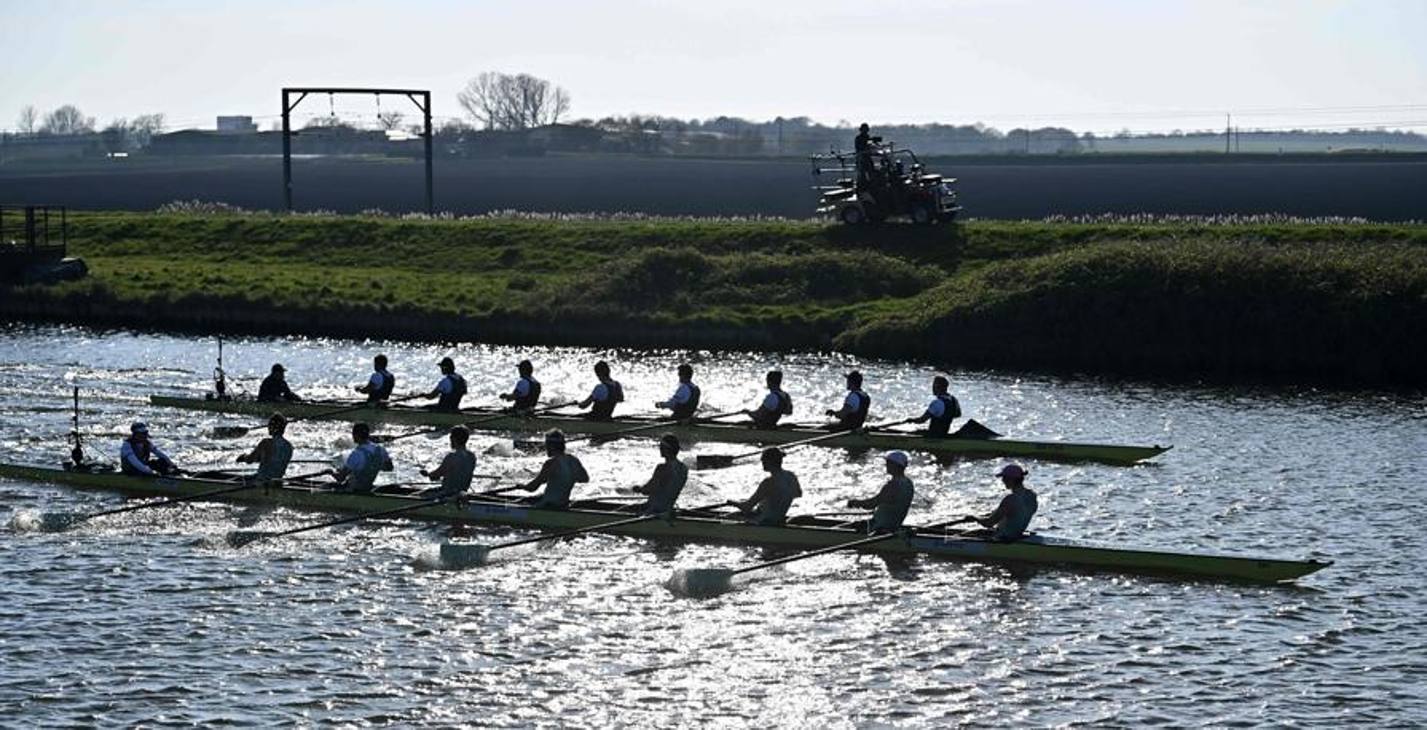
left=148, top=395, right=1170, bottom=465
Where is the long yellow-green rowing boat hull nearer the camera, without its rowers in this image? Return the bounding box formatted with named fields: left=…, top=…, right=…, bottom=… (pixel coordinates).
left=0, top=463, right=1331, bottom=583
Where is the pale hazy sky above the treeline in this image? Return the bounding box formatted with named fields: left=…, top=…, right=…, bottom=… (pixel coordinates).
left=0, top=0, right=1427, bottom=131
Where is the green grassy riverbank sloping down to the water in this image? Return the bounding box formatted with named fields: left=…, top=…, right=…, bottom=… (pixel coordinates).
left=0, top=214, right=1427, bottom=385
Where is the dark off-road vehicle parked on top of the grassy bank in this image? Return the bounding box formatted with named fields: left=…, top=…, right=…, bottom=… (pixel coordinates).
left=811, top=143, right=962, bottom=225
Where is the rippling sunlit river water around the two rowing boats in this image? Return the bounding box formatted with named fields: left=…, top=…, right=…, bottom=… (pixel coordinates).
left=0, top=327, right=1427, bottom=727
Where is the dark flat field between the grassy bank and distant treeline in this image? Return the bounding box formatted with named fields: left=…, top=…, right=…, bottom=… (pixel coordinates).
left=0, top=155, right=1427, bottom=221
